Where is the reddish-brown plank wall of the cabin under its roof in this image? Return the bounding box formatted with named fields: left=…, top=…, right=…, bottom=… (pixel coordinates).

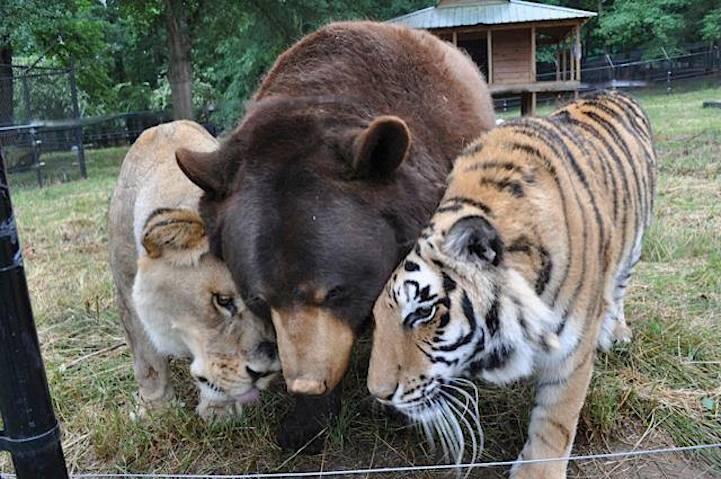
left=492, top=28, right=535, bottom=84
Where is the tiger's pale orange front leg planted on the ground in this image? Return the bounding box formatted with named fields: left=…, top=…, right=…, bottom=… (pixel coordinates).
left=511, top=335, right=596, bottom=479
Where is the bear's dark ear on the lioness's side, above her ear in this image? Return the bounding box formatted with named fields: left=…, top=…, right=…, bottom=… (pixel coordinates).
left=175, top=148, right=237, bottom=198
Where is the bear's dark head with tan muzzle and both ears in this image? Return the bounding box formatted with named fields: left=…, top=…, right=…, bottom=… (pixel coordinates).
left=176, top=97, right=428, bottom=394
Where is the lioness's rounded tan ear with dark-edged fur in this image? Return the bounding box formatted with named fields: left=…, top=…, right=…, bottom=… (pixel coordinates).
left=142, top=208, right=209, bottom=265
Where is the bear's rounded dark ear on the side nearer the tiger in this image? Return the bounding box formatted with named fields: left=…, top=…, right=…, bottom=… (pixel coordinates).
left=353, top=116, right=411, bottom=178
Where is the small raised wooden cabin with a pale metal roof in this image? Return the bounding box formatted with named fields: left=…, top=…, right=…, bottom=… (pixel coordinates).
left=389, top=0, right=596, bottom=114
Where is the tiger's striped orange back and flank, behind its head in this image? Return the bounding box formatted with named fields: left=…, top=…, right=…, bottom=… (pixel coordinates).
left=450, top=92, right=656, bottom=350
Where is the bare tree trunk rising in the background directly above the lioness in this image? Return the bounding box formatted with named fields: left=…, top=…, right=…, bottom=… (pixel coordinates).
left=165, top=0, right=193, bottom=120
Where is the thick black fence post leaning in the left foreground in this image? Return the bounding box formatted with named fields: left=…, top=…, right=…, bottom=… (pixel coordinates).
left=0, top=149, right=68, bottom=479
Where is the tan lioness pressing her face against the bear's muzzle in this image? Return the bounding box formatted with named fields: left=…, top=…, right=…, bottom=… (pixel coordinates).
left=109, top=121, right=280, bottom=418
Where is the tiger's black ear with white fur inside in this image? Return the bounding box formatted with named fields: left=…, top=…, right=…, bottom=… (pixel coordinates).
left=444, top=216, right=503, bottom=266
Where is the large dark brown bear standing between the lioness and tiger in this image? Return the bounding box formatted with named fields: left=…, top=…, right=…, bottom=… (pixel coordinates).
left=176, top=22, right=494, bottom=449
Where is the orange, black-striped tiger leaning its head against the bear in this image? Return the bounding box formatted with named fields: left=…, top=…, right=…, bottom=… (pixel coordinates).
left=368, top=92, right=656, bottom=479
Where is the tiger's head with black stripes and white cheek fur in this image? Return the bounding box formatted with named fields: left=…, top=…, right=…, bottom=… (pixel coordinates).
left=368, top=210, right=557, bottom=422
